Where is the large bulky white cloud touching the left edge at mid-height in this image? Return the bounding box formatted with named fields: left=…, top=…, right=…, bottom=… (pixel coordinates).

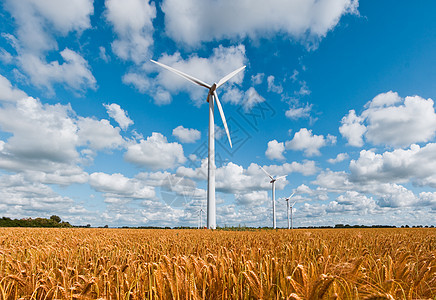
left=0, top=84, right=124, bottom=185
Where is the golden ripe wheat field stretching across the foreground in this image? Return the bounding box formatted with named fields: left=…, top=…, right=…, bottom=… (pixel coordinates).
left=0, top=228, right=436, bottom=300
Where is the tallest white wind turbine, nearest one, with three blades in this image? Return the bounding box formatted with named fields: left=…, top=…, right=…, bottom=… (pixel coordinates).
left=151, top=60, right=245, bottom=229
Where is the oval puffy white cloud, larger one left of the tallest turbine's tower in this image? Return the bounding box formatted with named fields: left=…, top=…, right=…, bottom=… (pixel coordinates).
left=124, top=132, right=186, bottom=169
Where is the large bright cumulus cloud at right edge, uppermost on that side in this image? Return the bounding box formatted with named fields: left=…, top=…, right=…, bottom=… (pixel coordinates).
left=339, top=91, right=436, bottom=147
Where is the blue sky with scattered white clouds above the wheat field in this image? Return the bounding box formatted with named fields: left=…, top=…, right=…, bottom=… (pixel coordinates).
left=0, top=0, right=436, bottom=227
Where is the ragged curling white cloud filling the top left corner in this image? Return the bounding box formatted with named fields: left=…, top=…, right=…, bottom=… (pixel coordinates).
left=5, top=0, right=96, bottom=93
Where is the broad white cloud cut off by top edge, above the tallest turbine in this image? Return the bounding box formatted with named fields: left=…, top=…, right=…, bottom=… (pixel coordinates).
left=162, top=0, right=358, bottom=45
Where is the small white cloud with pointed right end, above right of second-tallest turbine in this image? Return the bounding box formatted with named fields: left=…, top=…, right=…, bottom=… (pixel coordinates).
left=286, top=128, right=336, bottom=156
